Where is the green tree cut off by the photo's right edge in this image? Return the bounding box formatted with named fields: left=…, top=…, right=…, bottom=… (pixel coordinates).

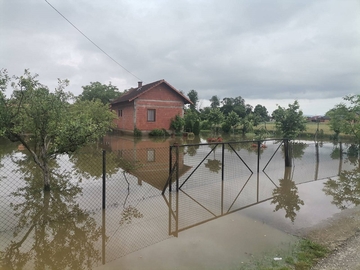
left=326, top=95, right=360, bottom=145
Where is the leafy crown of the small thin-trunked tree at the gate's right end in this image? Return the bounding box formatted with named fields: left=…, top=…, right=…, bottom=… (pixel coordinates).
left=272, top=100, right=306, bottom=139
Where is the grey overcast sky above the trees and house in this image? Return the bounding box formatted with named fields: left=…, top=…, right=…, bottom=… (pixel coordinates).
left=0, top=0, right=360, bottom=115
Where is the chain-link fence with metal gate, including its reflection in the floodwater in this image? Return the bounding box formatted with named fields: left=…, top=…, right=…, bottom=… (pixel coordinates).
left=0, top=140, right=347, bottom=269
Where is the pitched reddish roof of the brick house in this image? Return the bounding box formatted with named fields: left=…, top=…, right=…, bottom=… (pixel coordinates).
left=111, top=80, right=192, bottom=104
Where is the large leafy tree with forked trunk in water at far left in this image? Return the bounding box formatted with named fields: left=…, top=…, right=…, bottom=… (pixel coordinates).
left=0, top=70, right=116, bottom=191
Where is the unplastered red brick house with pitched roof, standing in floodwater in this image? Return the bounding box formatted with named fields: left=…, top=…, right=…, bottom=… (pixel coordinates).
left=111, top=80, right=192, bottom=134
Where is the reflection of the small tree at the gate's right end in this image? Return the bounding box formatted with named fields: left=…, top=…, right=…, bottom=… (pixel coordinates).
left=271, top=168, right=304, bottom=222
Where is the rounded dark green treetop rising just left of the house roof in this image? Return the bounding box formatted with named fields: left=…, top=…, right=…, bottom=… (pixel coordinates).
left=78, top=82, right=121, bottom=104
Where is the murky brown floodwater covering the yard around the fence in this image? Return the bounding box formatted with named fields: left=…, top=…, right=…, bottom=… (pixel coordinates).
left=0, top=136, right=360, bottom=269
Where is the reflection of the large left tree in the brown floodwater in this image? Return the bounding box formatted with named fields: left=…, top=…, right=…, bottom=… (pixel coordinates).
left=0, top=157, right=101, bottom=269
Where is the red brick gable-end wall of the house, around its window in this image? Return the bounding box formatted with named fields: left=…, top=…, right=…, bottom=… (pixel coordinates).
left=136, top=84, right=184, bottom=132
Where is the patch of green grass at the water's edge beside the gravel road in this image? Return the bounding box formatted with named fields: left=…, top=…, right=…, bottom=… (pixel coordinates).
left=238, top=239, right=329, bottom=270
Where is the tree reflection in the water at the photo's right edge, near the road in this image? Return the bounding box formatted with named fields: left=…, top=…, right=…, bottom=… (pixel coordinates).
left=323, top=168, right=360, bottom=209
